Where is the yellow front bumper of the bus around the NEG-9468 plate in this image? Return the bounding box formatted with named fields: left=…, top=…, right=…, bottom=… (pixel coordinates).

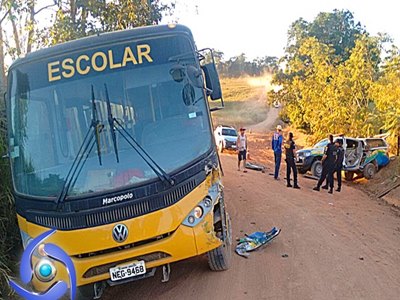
left=32, top=213, right=222, bottom=292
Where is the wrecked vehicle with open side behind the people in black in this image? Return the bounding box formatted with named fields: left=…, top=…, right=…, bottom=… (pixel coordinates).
left=296, top=136, right=389, bottom=180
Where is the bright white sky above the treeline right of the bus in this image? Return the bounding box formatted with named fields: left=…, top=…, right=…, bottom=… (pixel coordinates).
left=163, top=0, right=400, bottom=60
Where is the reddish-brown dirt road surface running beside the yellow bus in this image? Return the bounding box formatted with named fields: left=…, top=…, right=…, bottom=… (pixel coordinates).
left=104, top=154, right=400, bottom=300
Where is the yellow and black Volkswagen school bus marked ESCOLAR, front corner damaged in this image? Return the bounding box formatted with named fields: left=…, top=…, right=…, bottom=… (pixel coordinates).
left=6, top=25, right=231, bottom=299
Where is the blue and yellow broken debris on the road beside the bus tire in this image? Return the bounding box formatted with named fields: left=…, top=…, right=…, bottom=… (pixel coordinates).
left=235, top=227, right=281, bottom=258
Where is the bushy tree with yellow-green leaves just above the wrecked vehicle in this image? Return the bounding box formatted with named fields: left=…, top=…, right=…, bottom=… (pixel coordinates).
left=270, top=31, right=382, bottom=144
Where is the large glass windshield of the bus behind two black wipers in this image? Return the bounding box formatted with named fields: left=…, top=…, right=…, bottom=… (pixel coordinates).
left=9, top=37, right=211, bottom=198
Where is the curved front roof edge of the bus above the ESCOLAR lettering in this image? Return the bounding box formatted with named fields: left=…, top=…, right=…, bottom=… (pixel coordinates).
left=9, top=24, right=193, bottom=69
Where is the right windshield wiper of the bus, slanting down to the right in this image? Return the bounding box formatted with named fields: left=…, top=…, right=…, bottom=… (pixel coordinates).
left=104, top=84, right=175, bottom=185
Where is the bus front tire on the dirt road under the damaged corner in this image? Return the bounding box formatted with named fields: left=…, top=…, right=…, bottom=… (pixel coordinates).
left=207, top=214, right=232, bottom=271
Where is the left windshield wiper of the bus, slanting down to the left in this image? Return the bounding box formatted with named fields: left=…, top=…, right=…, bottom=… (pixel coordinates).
left=56, top=85, right=104, bottom=204
